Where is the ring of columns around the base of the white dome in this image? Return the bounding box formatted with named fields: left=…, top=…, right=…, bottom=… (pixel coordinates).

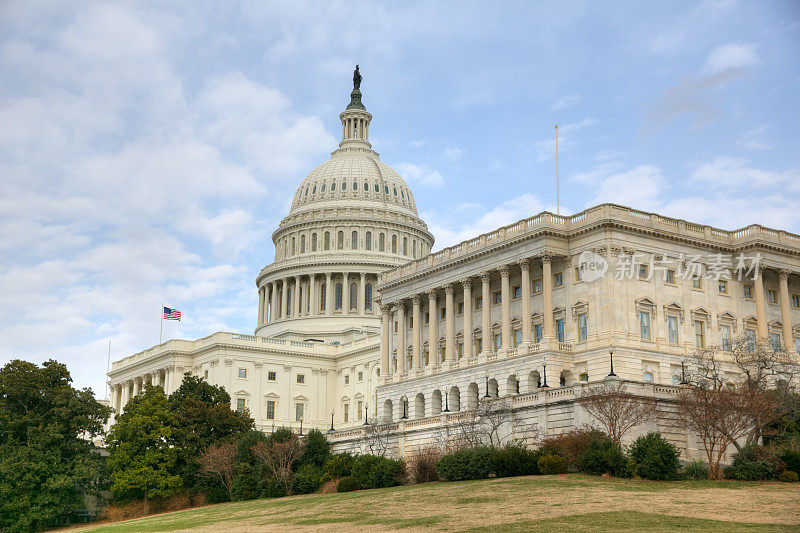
left=258, top=272, right=377, bottom=326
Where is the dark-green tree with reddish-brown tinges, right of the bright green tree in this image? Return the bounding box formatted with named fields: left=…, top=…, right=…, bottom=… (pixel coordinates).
left=169, top=374, right=253, bottom=491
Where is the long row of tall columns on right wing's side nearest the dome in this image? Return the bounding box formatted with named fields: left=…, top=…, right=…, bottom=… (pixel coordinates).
left=381, top=254, right=555, bottom=377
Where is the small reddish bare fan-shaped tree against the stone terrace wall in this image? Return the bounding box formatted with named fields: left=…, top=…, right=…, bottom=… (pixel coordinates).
left=578, top=381, right=656, bottom=443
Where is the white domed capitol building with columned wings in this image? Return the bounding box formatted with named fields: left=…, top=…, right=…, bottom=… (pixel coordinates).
left=108, top=77, right=800, bottom=457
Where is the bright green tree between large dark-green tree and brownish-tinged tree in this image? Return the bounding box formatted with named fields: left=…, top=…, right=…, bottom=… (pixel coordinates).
left=107, top=384, right=181, bottom=505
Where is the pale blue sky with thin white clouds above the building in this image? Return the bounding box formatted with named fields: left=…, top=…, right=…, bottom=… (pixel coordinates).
left=0, top=1, right=800, bottom=396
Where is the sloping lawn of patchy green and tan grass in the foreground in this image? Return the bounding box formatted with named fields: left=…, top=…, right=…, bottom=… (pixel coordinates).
left=75, top=475, right=800, bottom=533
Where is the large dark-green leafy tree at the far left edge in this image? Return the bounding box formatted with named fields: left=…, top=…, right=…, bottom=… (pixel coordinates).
left=0, top=360, right=110, bottom=531
